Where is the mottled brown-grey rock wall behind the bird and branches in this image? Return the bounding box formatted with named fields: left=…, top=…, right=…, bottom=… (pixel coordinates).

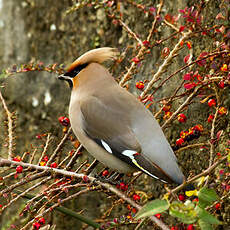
left=0, top=0, right=229, bottom=229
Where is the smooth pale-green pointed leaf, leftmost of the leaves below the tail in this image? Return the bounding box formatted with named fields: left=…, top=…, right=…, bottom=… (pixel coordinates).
left=135, top=199, right=169, bottom=220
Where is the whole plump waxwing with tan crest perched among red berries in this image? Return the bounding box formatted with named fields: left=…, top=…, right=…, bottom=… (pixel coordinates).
left=58, top=47, right=184, bottom=184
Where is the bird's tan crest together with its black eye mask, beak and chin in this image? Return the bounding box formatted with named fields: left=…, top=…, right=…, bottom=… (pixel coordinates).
left=58, top=47, right=118, bottom=88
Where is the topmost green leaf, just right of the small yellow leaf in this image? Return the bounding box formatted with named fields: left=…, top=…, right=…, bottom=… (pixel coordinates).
left=198, top=187, right=219, bottom=208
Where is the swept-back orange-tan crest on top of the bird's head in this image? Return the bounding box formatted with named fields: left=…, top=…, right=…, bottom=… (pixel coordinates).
left=67, top=47, right=118, bottom=72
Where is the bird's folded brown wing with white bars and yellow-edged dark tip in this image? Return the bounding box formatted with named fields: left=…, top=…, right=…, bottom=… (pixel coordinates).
left=80, top=96, right=172, bottom=182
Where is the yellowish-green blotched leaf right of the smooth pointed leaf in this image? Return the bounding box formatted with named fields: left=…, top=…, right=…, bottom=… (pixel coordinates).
left=169, top=201, right=197, bottom=224
